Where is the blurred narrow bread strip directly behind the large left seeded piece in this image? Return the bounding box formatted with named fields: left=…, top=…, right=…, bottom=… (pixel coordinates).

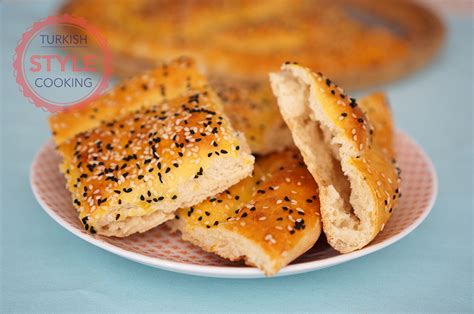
left=49, top=57, right=208, bottom=144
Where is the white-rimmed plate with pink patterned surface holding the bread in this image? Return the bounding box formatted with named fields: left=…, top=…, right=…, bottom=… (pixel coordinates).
left=30, top=132, right=437, bottom=278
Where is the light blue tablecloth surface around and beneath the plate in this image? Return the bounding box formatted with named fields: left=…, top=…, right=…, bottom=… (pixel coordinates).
left=0, top=1, right=473, bottom=312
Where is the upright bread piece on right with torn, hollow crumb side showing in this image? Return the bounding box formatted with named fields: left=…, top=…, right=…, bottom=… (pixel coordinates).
left=270, top=63, right=400, bottom=253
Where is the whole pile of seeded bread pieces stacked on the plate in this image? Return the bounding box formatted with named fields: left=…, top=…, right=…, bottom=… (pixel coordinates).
left=50, top=57, right=400, bottom=275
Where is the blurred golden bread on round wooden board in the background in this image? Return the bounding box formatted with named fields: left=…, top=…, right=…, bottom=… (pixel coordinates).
left=61, top=0, right=444, bottom=89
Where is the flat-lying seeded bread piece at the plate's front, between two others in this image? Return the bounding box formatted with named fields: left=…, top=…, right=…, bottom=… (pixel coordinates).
left=168, top=150, right=321, bottom=275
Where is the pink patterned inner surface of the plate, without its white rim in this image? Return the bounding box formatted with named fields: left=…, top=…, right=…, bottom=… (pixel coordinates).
left=31, top=132, right=436, bottom=267
